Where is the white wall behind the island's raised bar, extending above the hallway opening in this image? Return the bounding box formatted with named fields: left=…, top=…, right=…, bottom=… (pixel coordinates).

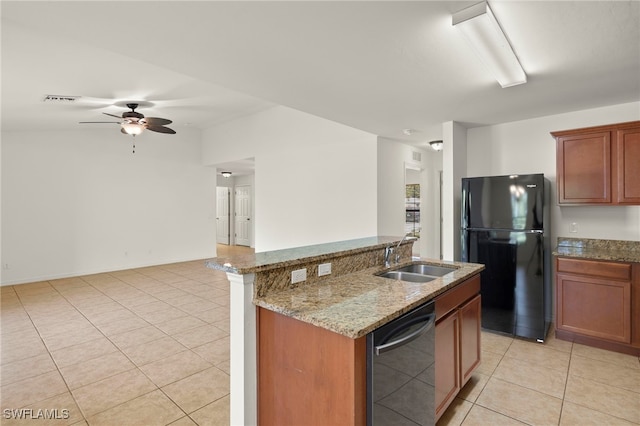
left=203, top=106, right=377, bottom=252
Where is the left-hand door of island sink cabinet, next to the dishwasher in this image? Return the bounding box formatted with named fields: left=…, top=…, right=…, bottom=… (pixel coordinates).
left=436, top=310, right=460, bottom=419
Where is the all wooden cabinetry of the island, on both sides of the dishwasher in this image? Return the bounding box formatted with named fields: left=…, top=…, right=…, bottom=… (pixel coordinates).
left=257, top=274, right=480, bottom=426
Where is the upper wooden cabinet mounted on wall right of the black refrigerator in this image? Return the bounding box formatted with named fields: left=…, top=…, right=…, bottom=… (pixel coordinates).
left=551, top=121, right=640, bottom=205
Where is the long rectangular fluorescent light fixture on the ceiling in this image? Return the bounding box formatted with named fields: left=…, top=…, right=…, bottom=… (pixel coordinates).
left=452, top=1, right=527, bottom=88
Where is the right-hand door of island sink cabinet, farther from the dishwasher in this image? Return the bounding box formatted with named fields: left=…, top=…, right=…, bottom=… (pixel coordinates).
left=458, top=295, right=481, bottom=386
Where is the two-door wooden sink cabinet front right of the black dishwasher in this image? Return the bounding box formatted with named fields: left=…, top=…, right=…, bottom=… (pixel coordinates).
left=435, top=275, right=480, bottom=420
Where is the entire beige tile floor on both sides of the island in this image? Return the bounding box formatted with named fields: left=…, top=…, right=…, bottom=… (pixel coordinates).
left=0, top=246, right=640, bottom=426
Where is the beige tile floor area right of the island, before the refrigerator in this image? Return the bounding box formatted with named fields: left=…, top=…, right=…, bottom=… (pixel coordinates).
left=438, top=331, right=640, bottom=426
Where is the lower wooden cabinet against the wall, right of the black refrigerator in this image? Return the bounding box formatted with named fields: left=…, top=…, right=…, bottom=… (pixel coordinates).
left=556, top=257, right=640, bottom=355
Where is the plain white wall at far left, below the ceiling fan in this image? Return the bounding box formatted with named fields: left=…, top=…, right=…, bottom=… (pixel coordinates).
left=2, top=129, right=216, bottom=285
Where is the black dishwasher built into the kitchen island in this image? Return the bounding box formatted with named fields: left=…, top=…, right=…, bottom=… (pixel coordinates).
left=367, top=302, right=435, bottom=426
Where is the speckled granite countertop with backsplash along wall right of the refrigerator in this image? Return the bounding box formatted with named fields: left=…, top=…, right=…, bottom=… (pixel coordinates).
left=553, top=237, right=640, bottom=263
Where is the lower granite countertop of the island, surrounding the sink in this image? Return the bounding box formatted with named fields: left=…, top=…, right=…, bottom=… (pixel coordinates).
left=254, top=259, right=484, bottom=339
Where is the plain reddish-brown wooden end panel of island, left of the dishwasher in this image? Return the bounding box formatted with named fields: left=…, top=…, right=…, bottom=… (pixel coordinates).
left=258, top=308, right=367, bottom=426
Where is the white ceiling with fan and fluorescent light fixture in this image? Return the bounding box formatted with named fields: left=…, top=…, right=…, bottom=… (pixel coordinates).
left=1, top=0, right=640, bottom=155
